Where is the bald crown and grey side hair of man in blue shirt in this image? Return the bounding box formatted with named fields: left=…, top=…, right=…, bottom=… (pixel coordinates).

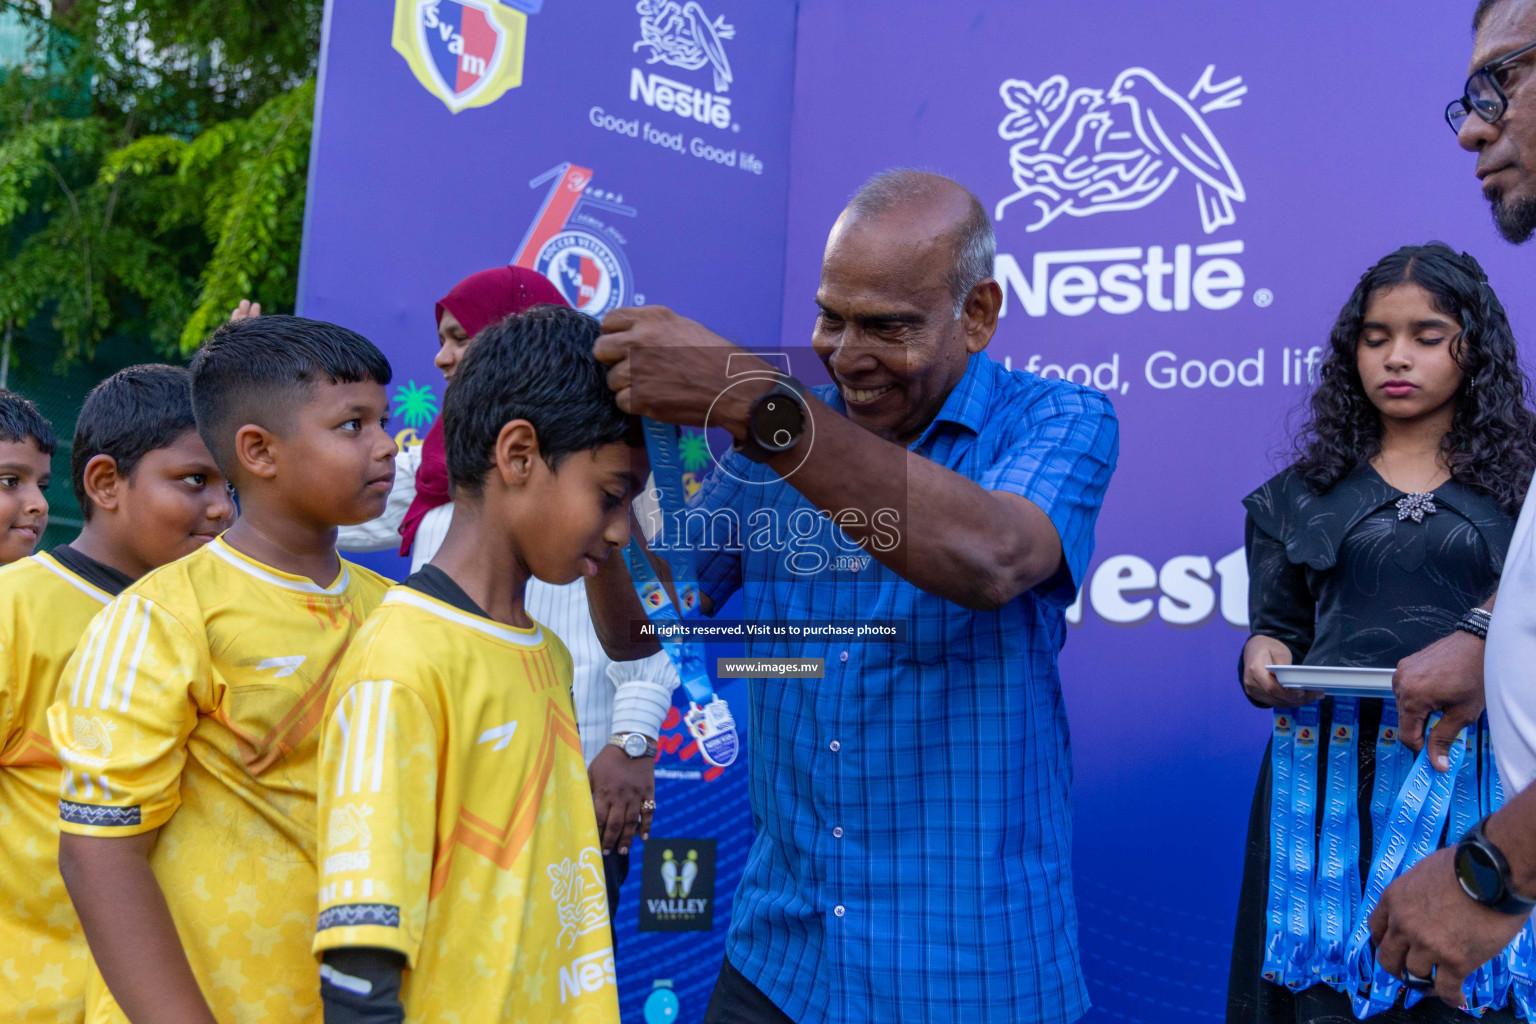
left=833, top=169, right=997, bottom=318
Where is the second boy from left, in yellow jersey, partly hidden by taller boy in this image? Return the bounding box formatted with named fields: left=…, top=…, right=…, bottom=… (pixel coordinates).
left=0, top=365, right=235, bottom=1024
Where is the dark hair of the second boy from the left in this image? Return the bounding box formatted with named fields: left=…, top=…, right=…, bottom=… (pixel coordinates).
left=69, top=362, right=197, bottom=522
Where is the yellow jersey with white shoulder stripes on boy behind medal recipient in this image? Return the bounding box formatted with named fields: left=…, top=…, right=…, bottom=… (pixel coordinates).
left=48, top=540, right=389, bottom=1024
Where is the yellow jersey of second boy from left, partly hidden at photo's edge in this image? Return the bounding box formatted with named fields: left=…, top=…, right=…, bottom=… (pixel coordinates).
left=0, top=554, right=117, bottom=1024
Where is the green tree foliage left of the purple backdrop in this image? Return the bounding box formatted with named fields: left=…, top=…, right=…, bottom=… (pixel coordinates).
left=0, top=0, right=323, bottom=368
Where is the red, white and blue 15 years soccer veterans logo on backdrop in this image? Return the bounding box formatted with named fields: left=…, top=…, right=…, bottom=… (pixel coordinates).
left=511, top=164, right=645, bottom=316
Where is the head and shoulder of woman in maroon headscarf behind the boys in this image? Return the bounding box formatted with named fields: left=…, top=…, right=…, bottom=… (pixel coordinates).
left=336, top=267, right=570, bottom=573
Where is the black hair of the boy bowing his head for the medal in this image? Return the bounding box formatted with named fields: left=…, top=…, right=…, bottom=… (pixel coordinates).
left=442, top=306, right=630, bottom=494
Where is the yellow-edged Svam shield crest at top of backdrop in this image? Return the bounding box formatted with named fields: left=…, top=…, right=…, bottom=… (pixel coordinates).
left=395, top=0, right=528, bottom=114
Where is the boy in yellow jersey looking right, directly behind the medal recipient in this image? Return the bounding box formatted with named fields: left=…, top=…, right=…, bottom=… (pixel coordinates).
left=48, top=316, right=395, bottom=1024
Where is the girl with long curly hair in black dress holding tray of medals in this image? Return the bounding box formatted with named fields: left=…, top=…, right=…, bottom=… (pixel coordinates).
left=1227, top=243, right=1536, bottom=1024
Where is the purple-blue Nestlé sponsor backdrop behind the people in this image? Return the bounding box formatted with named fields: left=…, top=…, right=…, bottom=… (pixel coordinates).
left=301, top=0, right=1533, bottom=1024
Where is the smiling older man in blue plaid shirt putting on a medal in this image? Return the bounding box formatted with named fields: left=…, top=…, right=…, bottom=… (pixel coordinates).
left=590, top=170, right=1118, bottom=1024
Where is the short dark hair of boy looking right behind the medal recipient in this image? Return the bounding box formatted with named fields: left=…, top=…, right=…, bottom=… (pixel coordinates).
left=192, top=316, right=390, bottom=479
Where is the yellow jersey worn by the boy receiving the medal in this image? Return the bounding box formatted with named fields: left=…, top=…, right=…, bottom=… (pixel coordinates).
left=315, top=577, right=619, bottom=1024
